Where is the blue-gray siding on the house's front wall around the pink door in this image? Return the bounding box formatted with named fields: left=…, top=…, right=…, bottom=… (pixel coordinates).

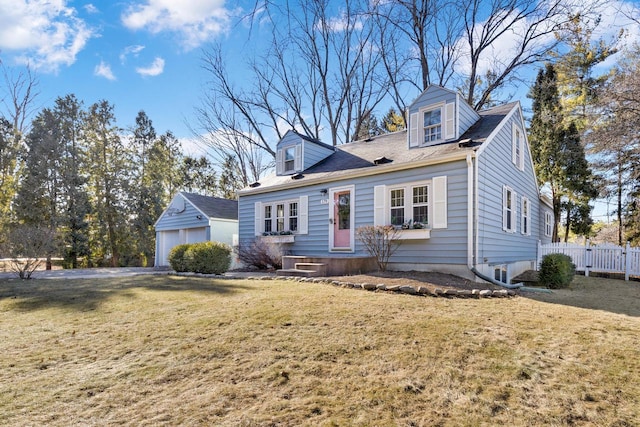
left=239, top=161, right=467, bottom=264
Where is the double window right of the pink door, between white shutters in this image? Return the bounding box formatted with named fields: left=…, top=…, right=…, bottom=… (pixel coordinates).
left=389, top=184, right=429, bottom=226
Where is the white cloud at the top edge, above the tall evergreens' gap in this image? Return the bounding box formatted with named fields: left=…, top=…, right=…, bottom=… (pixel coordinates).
left=122, top=0, right=230, bottom=49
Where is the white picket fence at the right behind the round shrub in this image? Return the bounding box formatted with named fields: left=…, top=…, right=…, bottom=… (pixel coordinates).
left=538, top=240, right=640, bottom=280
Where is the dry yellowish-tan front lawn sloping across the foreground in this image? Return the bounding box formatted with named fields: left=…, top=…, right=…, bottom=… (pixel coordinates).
left=0, top=276, right=640, bottom=426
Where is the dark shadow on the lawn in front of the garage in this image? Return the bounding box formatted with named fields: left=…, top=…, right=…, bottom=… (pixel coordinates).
left=0, top=275, right=249, bottom=312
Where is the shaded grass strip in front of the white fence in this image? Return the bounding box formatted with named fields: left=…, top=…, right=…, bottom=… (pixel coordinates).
left=522, top=276, right=640, bottom=317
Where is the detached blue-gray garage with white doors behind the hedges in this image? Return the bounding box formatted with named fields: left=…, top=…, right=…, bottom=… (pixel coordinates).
left=155, top=191, right=238, bottom=267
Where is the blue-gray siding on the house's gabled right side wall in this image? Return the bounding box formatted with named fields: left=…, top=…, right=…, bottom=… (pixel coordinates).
left=476, top=107, right=544, bottom=265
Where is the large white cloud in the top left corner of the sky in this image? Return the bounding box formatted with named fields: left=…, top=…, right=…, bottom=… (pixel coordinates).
left=0, top=0, right=95, bottom=72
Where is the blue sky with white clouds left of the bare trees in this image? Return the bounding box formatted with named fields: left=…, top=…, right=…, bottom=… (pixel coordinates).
left=0, top=0, right=249, bottom=150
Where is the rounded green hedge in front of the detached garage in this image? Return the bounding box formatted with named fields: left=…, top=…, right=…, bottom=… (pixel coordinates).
left=169, top=242, right=231, bottom=274
